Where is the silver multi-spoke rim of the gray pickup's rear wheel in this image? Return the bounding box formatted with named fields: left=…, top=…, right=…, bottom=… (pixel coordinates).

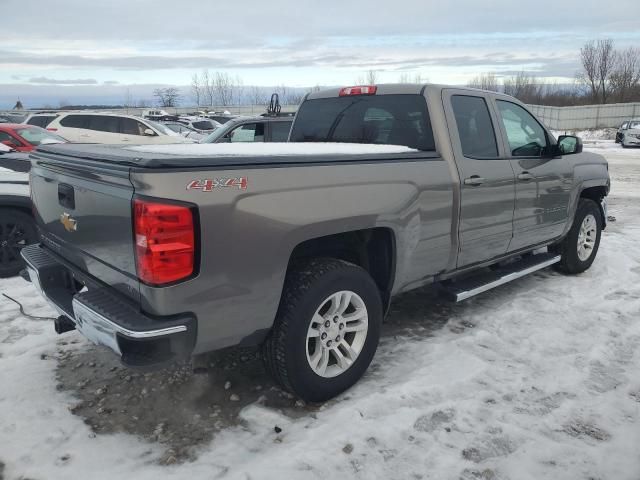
left=306, top=290, right=369, bottom=378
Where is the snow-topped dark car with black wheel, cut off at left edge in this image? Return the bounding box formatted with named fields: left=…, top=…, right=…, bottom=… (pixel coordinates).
left=0, top=143, right=38, bottom=278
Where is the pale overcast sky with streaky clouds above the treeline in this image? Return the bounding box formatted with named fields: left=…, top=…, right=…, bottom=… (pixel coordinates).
left=0, top=0, right=640, bottom=105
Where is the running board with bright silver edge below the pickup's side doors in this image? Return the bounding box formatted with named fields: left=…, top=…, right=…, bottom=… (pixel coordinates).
left=442, top=253, right=560, bottom=302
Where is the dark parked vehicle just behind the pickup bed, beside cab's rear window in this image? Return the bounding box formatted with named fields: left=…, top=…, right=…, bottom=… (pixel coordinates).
left=200, top=116, right=293, bottom=143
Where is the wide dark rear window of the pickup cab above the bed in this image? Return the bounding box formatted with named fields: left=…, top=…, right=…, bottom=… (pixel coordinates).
left=291, top=95, right=435, bottom=150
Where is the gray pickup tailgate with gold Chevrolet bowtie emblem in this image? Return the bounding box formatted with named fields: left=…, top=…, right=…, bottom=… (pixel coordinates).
left=31, top=151, right=140, bottom=303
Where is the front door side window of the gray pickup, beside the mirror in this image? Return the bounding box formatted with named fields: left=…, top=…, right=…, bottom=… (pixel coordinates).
left=496, top=100, right=547, bottom=157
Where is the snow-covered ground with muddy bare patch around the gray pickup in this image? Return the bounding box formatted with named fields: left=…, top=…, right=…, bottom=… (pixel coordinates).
left=0, top=142, right=640, bottom=480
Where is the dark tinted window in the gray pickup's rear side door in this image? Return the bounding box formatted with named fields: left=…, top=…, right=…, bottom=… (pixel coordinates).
left=451, top=95, right=498, bottom=158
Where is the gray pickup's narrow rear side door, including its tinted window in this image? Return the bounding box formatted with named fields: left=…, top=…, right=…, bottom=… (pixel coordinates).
left=443, top=89, right=515, bottom=268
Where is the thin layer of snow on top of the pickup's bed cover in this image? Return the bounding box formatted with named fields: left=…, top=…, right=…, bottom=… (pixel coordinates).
left=127, top=143, right=418, bottom=157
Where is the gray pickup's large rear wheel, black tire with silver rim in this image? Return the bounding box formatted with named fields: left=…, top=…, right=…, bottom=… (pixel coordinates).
left=263, top=258, right=383, bottom=402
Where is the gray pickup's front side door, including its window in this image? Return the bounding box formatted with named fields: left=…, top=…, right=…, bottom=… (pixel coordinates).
left=496, top=100, right=573, bottom=251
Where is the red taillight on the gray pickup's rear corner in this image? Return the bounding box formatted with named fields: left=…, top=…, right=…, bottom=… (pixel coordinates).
left=133, top=199, right=196, bottom=285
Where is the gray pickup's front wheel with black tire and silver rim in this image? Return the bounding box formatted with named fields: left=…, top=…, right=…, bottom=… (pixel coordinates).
left=552, top=198, right=603, bottom=274
